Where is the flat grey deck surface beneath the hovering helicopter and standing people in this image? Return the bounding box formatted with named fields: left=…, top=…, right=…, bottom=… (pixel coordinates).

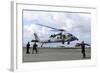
left=23, top=48, right=91, bottom=62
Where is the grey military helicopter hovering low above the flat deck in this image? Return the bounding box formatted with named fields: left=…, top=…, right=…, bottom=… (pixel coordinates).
left=31, top=24, right=78, bottom=47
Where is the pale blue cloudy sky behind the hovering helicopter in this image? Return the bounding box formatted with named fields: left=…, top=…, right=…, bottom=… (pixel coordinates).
left=23, top=11, right=91, bottom=47
